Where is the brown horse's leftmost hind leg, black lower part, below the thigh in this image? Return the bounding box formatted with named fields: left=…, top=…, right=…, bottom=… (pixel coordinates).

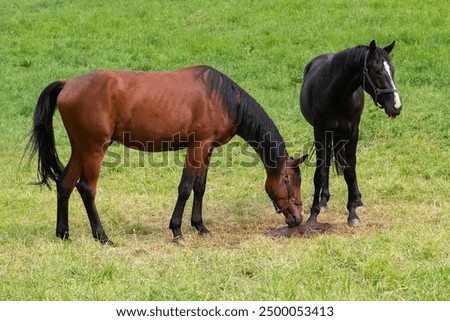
left=56, top=155, right=81, bottom=240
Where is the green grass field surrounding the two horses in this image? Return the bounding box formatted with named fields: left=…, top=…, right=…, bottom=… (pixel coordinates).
left=0, top=0, right=450, bottom=300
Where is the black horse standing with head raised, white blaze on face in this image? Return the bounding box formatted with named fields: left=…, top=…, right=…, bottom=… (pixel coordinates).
left=300, top=40, right=402, bottom=226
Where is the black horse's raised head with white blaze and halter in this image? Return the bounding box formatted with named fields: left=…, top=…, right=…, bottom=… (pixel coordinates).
left=362, top=40, right=402, bottom=118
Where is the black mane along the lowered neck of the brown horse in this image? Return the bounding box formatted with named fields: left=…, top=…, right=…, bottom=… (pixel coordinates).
left=198, top=66, right=287, bottom=173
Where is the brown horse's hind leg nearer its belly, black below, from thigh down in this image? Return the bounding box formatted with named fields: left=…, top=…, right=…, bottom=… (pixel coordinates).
left=77, top=153, right=113, bottom=245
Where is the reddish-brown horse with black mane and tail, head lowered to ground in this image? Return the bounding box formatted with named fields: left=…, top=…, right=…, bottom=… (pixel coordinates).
left=28, top=66, right=306, bottom=244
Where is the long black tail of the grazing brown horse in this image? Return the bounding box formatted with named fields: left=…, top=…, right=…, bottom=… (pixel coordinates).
left=27, top=81, right=64, bottom=188
